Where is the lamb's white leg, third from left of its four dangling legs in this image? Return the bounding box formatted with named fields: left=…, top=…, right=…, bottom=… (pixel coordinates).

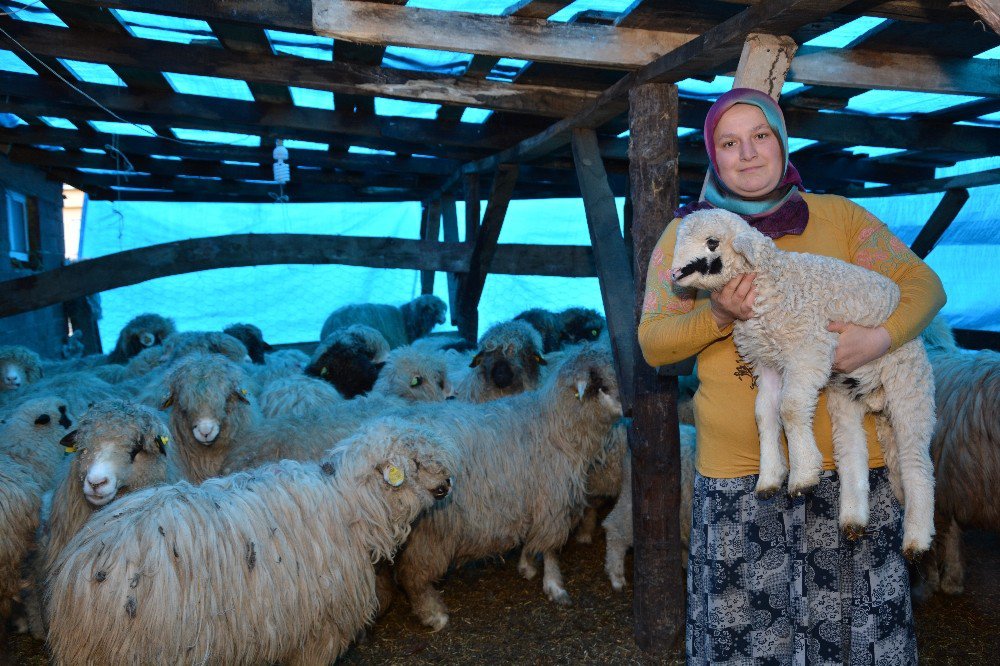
left=826, top=386, right=868, bottom=541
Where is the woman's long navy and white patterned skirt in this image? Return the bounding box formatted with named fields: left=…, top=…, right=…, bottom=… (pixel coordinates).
left=686, top=468, right=917, bottom=666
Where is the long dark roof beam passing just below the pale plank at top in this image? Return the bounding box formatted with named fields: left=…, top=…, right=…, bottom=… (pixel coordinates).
left=3, top=21, right=597, bottom=117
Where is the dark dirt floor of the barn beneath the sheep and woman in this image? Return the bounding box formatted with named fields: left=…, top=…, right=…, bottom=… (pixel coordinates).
left=0, top=532, right=1000, bottom=666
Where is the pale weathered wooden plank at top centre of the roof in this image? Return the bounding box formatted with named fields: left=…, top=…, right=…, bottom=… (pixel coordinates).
left=313, top=0, right=694, bottom=69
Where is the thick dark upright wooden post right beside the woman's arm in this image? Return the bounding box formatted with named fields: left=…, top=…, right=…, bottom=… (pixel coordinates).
left=628, top=83, right=685, bottom=658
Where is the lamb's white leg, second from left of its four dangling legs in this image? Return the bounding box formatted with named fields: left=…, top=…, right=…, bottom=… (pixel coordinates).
left=780, top=360, right=832, bottom=497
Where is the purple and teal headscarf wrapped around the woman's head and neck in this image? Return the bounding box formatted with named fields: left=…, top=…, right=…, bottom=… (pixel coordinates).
left=675, top=88, right=809, bottom=238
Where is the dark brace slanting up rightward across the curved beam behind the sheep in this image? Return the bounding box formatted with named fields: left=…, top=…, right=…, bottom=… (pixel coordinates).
left=458, top=165, right=518, bottom=343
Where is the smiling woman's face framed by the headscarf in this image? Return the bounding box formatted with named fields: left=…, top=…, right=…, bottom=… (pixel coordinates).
left=713, top=104, right=785, bottom=199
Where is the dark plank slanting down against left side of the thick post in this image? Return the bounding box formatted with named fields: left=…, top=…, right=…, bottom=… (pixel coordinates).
left=572, top=129, right=636, bottom=404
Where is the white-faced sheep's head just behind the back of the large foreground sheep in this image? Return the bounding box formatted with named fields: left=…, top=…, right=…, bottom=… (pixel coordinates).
left=60, top=400, right=170, bottom=507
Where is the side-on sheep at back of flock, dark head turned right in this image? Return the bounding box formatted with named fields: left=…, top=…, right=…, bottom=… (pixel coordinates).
left=320, top=294, right=448, bottom=349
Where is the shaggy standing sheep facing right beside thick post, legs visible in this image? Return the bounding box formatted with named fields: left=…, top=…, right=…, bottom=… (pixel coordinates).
left=396, top=346, right=622, bottom=631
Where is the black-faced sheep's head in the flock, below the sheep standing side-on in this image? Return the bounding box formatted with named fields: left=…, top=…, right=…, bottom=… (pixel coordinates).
left=305, top=324, right=389, bottom=398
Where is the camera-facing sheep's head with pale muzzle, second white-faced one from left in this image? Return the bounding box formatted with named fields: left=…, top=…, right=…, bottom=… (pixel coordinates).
left=161, top=352, right=260, bottom=483
